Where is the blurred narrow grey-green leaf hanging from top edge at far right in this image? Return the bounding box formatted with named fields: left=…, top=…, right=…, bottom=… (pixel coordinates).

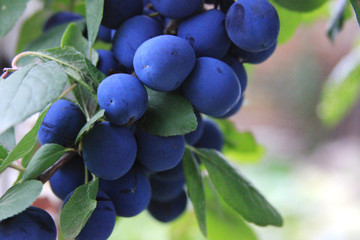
left=327, top=0, right=351, bottom=41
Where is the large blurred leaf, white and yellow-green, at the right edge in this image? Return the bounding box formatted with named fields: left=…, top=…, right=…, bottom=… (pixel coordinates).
left=318, top=47, right=360, bottom=126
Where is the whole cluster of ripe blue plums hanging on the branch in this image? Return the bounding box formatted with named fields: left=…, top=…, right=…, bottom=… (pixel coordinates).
left=0, top=0, right=279, bottom=240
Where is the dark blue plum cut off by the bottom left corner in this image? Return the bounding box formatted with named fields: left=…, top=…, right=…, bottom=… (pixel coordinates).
left=0, top=207, right=56, bottom=240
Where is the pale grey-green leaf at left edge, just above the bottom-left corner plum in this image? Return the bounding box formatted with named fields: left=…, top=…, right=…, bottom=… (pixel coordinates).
left=0, top=180, right=43, bottom=222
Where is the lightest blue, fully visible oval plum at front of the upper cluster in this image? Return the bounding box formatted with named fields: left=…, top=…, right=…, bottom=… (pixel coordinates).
left=134, top=35, right=196, bottom=91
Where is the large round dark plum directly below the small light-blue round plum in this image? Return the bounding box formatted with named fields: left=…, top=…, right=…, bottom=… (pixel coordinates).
left=82, top=122, right=137, bottom=180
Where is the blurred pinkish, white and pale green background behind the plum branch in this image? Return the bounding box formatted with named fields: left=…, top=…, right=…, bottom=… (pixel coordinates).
left=0, top=0, right=360, bottom=240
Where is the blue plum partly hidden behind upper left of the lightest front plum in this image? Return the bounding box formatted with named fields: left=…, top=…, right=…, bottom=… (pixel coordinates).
left=112, top=15, right=163, bottom=69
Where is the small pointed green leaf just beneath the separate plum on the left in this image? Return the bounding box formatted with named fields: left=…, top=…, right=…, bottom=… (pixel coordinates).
left=23, top=143, right=69, bottom=181
